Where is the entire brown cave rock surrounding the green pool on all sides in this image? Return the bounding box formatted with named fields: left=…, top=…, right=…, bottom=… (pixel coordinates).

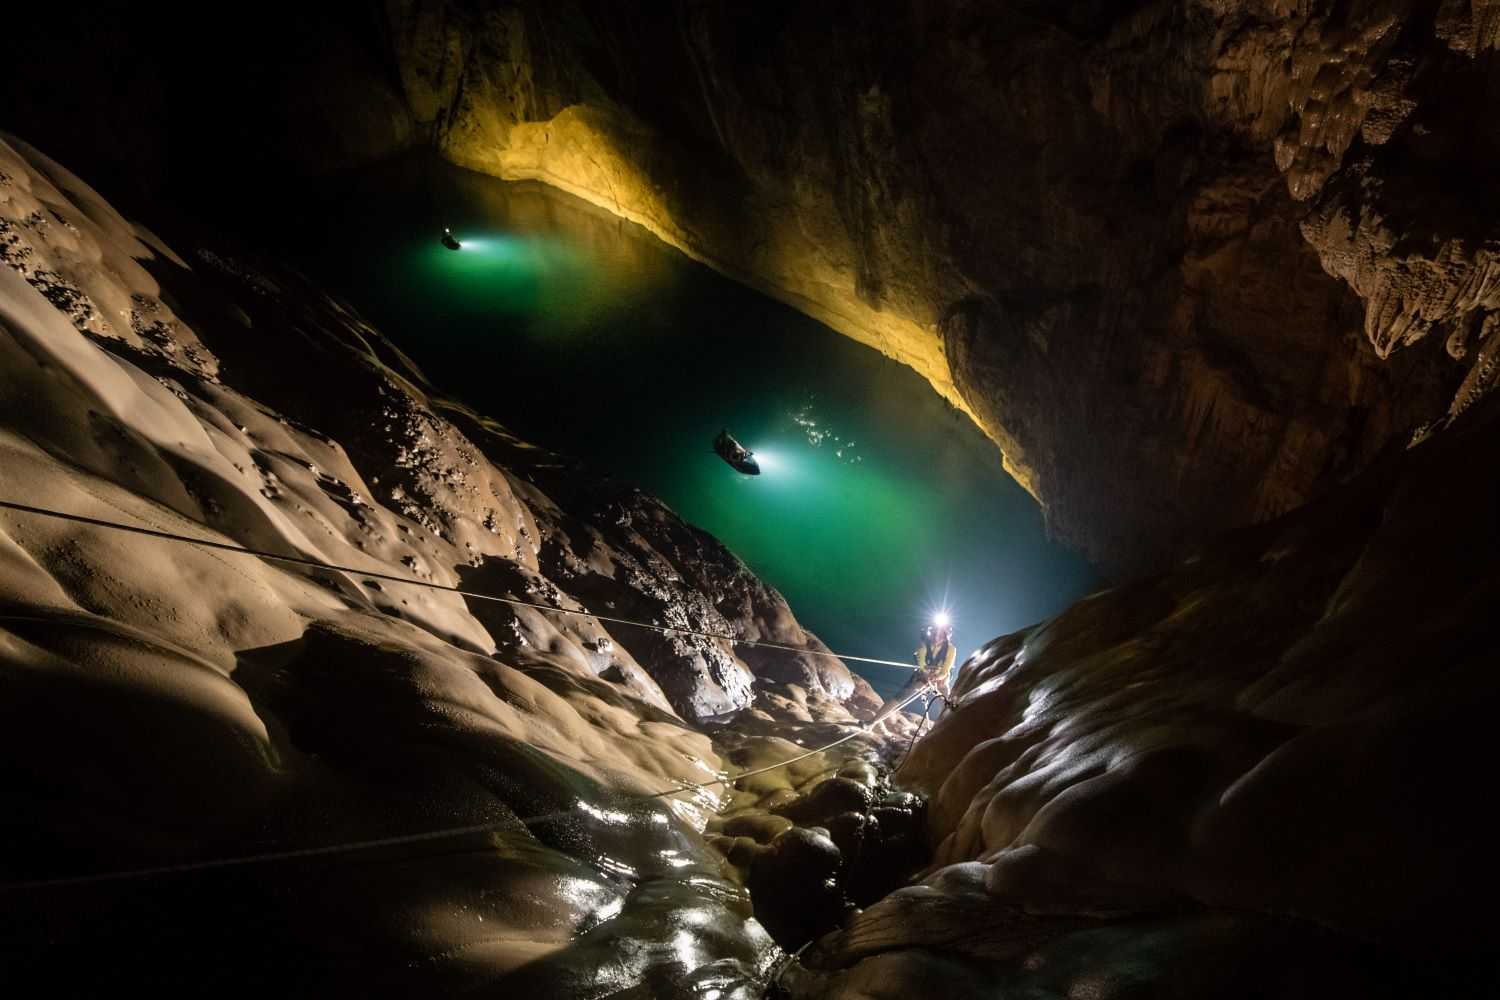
left=0, top=0, right=1500, bottom=999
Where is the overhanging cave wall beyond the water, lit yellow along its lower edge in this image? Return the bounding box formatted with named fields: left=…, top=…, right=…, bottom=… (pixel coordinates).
left=5, top=0, right=1500, bottom=570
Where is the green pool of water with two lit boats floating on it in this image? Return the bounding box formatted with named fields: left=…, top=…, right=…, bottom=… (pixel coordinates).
left=278, top=159, right=1097, bottom=693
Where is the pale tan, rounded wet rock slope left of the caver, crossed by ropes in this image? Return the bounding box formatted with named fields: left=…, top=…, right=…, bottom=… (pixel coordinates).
left=0, top=138, right=909, bottom=997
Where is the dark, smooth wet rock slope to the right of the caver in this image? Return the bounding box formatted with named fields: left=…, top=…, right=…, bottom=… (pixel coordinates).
left=780, top=386, right=1500, bottom=997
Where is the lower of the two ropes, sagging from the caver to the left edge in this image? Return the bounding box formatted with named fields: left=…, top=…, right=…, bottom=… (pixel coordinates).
left=0, top=685, right=932, bottom=892
